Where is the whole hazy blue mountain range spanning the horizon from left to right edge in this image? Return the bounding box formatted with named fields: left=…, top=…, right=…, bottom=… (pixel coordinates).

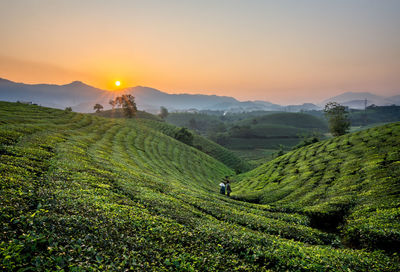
left=0, top=78, right=400, bottom=113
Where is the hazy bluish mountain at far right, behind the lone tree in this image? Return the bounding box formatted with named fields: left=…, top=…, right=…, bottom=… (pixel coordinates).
left=321, top=92, right=400, bottom=109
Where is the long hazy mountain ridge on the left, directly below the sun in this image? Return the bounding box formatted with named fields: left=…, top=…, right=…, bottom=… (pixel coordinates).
left=0, top=78, right=245, bottom=112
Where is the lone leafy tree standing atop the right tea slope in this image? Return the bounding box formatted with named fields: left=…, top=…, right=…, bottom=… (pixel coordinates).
left=324, top=102, right=350, bottom=136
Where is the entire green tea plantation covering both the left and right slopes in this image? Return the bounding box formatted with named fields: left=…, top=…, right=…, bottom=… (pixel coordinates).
left=0, top=102, right=400, bottom=271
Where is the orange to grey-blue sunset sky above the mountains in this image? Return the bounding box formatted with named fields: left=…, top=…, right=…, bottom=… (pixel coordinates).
left=0, top=0, right=400, bottom=104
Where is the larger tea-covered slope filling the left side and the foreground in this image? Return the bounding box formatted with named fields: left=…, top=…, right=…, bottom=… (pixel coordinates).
left=0, top=102, right=399, bottom=271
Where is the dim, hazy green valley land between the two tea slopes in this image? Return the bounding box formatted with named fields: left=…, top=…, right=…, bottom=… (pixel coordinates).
left=166, top=111, right=327, bottom=168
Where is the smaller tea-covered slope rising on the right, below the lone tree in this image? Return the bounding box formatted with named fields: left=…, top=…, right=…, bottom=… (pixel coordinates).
left=235, top=123, right=400, bottom=250
